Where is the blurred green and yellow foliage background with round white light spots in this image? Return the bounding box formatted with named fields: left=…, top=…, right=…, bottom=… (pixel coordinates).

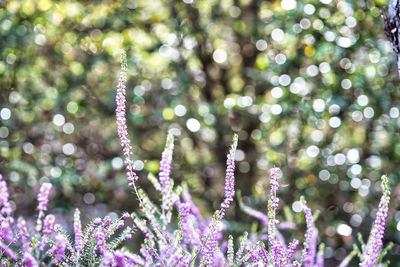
left=0, top=0, right=400, bottom=266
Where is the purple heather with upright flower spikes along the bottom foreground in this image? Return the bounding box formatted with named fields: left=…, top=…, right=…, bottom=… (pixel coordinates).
left=0, top=52, right=391, bottom=267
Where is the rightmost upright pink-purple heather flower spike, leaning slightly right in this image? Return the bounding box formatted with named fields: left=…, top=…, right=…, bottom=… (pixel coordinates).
left=360, top=175, right=390, bottom=267
